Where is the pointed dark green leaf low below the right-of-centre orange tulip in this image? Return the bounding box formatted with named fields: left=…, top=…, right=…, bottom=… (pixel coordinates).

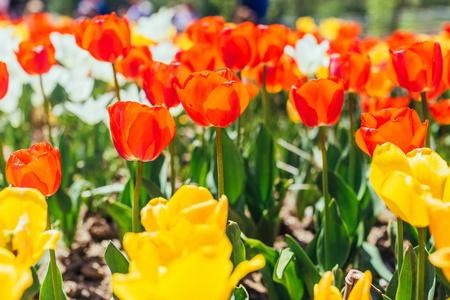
left=317, top=199, right=351, bottom=270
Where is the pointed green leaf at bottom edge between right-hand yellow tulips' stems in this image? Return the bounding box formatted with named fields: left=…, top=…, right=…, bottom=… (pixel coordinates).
left=395, top=246, right=417, bottom=300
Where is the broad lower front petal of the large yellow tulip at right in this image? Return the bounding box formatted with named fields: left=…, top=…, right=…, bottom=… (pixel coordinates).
left=377, top=171, right=430, bottom=228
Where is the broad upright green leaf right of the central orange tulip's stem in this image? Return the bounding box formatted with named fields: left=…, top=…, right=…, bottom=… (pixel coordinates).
left=214, top=129, right=245, bottom=206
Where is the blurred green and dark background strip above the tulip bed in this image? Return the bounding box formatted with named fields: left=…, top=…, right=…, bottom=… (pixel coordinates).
left=0, top=0, right=450, bottom=36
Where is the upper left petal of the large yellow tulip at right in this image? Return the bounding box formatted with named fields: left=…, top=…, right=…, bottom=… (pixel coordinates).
left=369, top=143, right=413, bottom=195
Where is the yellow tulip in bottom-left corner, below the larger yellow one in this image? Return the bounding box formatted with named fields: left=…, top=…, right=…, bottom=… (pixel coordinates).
left=0, top=248, right=33, bottom=300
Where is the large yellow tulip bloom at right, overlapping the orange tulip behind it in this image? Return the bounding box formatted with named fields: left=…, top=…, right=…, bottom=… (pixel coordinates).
left=369, top=143, right=450, bottom=227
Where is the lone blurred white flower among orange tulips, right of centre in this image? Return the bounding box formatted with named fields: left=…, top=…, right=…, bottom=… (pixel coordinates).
left=284, top=33, right=330, bottom=77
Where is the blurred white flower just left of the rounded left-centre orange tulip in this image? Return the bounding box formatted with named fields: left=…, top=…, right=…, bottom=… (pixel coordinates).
left=64, top=93, right=114, bottom=125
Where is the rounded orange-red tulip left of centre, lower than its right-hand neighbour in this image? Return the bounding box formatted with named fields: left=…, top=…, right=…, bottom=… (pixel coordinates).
left=108, top=101, right=176, bottom=161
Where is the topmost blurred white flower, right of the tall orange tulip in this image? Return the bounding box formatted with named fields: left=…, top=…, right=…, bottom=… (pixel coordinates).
left=134, top=7, right=176, bottom=43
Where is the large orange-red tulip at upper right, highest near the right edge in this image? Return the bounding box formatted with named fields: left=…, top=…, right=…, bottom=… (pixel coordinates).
left=386, top=41, right=443, bottom=93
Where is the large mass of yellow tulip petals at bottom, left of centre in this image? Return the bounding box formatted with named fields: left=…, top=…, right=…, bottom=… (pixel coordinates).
left=112, top=186, right=265, bottom=300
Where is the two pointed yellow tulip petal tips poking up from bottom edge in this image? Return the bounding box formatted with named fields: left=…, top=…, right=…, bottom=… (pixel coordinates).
left=314, top=271, right=372, bottom=300
